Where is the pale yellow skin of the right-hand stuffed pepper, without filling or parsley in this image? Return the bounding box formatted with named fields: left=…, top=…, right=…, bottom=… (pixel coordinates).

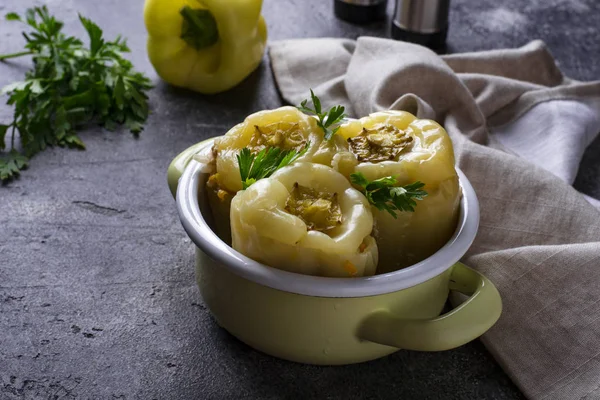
left=334, top=111, right=461, bottom=274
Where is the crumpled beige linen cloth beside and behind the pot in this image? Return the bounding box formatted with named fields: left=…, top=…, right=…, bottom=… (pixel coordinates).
left=269, top=37, right=600, bottom=400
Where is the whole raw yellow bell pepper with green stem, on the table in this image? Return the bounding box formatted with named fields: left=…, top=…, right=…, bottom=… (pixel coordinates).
left=144, top=0, right=267, bottom=94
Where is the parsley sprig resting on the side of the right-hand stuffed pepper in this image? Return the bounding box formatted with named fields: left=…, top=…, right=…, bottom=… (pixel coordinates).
left=350, top=172, right=427, bottom=218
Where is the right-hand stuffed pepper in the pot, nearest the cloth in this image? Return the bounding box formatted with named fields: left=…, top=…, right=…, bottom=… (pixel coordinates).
left=334, top=111, right=461, bottom=273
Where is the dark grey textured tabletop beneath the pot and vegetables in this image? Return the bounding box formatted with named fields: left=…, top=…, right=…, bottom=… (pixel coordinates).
left=0, top=0, right=600, bottom=400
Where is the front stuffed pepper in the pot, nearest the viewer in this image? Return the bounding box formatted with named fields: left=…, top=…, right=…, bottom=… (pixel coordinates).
left=231, top=162, right=377, bottom=277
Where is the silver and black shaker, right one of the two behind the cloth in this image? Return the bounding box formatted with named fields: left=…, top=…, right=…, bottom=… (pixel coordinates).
left=391, top=0, right=450, bottom=53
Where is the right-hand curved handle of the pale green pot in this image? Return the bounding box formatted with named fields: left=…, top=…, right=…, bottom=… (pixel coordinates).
left=358, top=263, right=502, bottom=351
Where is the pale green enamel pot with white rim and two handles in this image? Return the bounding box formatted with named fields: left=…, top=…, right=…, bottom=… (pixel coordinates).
left=168, top=140, right=502, bottom=365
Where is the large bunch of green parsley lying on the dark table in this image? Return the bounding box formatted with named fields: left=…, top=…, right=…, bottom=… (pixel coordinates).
left=0, top=6, right=152, bottom=180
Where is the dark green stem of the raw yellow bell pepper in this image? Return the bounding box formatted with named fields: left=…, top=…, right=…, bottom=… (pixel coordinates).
left=179, top=6, right=219, bottom=50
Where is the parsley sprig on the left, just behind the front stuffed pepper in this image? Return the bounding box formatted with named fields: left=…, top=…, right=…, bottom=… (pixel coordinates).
left=237, top=142, right=310, bottom=189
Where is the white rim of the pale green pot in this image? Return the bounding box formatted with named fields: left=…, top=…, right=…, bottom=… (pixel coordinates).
left=176, top=147, right=479, bottom=297
